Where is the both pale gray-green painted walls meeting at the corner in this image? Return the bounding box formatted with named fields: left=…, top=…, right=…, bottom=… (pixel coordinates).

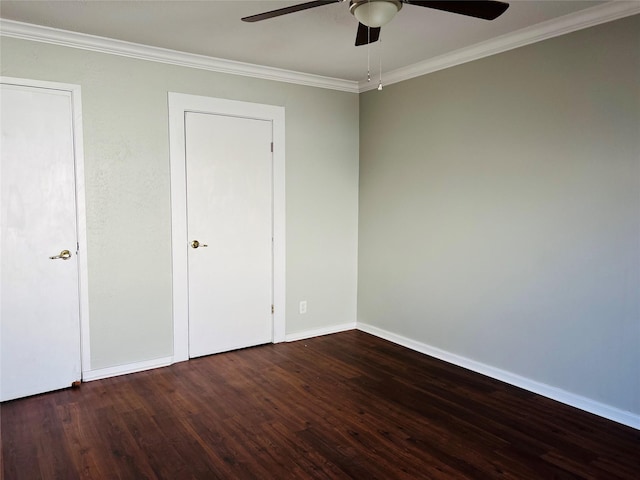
left=0, top=16, right=640, bottom=422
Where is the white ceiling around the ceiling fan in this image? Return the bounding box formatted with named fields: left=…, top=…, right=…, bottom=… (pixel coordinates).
left=0, top=0, right=624, bottom=82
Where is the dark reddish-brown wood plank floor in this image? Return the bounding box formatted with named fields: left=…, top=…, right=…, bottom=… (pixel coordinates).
left=1, top=331, right=640, bottom=480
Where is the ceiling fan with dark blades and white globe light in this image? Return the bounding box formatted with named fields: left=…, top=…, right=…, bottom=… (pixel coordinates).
left=242, top=0, right=509, bottom=46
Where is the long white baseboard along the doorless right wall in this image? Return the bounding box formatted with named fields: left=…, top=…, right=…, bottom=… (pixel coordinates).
left=357, top=322, right=640, bottom=430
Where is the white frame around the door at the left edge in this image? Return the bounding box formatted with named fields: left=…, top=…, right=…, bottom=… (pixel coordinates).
left=0, top=76, right=91, bottom=378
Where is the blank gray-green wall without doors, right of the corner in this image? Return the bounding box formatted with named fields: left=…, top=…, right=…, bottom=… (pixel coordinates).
left=358, top=16, right=640, bottom=413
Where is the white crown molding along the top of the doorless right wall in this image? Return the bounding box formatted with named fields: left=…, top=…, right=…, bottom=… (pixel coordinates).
left=358, top=0, right=640, bottom=93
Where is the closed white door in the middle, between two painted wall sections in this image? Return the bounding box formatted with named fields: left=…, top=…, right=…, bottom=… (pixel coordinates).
left=185, top=112, right=273, bottom=357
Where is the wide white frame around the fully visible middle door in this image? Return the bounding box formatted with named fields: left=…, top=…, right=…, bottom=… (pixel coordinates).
left=168, top=92, right=286, bottom=363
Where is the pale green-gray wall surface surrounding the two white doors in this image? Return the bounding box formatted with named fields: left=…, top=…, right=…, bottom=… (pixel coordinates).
left=0, top=38, right=358, bottom=369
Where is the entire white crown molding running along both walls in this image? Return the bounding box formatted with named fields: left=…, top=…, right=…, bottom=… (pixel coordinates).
left=0, top=0, right=640, bottom=93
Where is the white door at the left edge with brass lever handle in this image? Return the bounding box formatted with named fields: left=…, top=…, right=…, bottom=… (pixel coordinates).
left=0, top=84, right=81, bottom=401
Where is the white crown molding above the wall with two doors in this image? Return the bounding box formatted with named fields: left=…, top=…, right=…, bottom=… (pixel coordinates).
left=0, top=19, right=359, bottom=93
